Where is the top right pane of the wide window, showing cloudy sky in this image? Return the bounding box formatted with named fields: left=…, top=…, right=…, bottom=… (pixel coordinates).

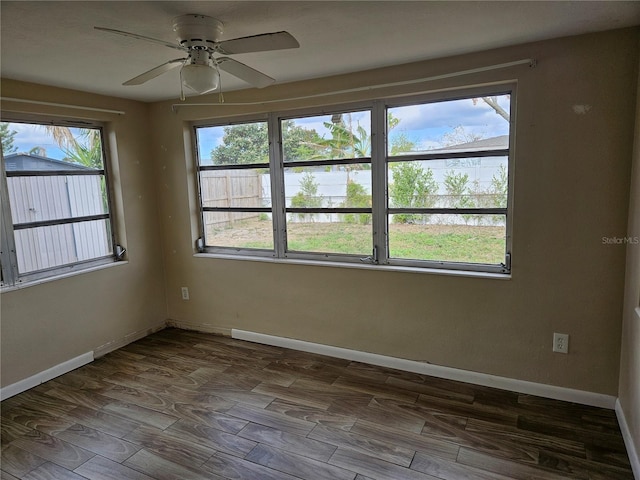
left=387, top=95, right=511, bottom=156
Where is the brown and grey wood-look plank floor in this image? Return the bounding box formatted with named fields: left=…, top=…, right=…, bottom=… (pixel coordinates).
left=0, top=329, right=633, bottom=480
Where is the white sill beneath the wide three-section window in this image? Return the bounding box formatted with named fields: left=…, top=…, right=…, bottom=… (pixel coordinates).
left=193, top=253, right=511, bottom=280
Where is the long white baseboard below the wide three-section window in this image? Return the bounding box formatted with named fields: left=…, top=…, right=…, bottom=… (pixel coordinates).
left=231, top=329, right=616, bottom=410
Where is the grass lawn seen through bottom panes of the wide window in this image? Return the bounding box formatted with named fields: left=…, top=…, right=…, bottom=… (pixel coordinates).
left=209, top=220, right=505, bottom=264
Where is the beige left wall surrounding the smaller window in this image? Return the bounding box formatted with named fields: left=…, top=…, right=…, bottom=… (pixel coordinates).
left=0, top=79, right=166, bottom=387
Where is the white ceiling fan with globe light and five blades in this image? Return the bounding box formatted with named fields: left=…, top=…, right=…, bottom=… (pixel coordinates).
left=94, top=14, right=300, bottom=98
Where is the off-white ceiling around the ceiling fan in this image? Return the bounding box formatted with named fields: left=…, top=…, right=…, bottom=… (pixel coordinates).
left=0, top=0, right=640, bottom=101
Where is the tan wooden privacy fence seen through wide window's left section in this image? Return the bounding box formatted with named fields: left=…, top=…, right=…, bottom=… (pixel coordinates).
left=200, top=170, right=262, bottom=231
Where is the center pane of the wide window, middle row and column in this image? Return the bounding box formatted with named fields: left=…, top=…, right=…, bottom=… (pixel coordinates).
left=284, top=163, right=371, bottom=208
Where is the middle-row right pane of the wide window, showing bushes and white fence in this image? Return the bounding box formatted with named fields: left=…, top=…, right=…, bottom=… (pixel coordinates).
left=388, top=157, right=508, bottom=208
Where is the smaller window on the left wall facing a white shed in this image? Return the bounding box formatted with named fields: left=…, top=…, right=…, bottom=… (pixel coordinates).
left=0, top=122, right=120, bottom=285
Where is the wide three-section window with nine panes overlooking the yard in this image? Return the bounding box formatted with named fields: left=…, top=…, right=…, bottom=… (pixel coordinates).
left=194, top=86, right=514, bottom=273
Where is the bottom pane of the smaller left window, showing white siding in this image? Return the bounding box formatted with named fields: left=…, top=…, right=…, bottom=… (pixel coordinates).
left=14, top=220, right=113, bottom=273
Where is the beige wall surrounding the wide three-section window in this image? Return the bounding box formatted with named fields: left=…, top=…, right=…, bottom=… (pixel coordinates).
left=151, top=30, right=638, bottom=395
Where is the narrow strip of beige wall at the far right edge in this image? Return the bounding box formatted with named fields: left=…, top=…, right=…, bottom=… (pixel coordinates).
left=618, top=46, right=640, bottom=464
